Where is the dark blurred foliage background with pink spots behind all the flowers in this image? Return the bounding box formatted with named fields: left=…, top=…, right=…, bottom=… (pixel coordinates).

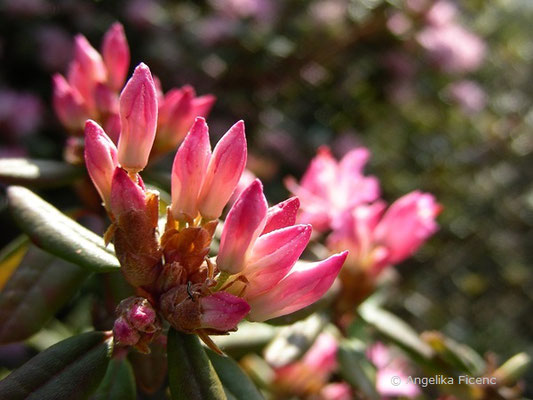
left=0, top=0, right=533, bottom=394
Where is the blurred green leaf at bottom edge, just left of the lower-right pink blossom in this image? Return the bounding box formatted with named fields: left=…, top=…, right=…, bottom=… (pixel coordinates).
left=337, top=341, right=380, bottom=400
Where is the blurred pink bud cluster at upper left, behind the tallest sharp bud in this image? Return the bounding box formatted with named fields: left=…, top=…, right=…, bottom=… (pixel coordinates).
left=53, top=23, right=215, bottom=163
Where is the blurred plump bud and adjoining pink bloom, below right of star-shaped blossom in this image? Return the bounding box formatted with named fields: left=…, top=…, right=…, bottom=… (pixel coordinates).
left=328, top=191, right=441, bottom=276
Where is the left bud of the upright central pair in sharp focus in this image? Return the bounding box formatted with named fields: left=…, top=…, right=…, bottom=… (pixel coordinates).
left=171, top=118, right=211, bottom=219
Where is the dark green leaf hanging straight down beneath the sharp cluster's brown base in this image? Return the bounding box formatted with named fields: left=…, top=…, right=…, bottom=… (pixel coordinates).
left=168, top=328, right=227, bottom=400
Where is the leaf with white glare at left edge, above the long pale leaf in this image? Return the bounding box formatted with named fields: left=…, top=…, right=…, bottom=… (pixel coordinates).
left=0, top=158, right=84, bottom=188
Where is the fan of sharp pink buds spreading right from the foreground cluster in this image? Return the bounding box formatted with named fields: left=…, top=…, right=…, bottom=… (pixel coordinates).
left=217, top=180, right=347, bottom=321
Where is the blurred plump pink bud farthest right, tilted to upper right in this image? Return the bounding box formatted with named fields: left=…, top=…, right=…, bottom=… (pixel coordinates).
left=375, top=191, right=441, bottom=264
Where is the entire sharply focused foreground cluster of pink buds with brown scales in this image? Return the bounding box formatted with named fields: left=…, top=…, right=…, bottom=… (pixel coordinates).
left=85, top=64, right=347, bottom=350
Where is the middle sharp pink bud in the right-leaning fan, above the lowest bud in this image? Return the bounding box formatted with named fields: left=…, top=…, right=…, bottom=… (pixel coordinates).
left=244, top=225, right=312, bottom=299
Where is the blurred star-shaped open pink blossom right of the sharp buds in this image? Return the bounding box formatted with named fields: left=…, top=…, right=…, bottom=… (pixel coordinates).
left=285, top=147, right=380, bottom=231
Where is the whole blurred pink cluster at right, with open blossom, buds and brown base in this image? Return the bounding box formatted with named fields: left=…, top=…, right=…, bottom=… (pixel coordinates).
left=287, top=148, right=441, bottom=308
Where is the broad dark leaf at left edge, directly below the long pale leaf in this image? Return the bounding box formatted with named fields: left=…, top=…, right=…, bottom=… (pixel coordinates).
left=0, top=246, right=89, bottom=343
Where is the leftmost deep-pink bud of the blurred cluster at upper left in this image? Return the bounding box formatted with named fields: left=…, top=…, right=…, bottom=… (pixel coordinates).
left=52, top=74, right=88, bottom=130
